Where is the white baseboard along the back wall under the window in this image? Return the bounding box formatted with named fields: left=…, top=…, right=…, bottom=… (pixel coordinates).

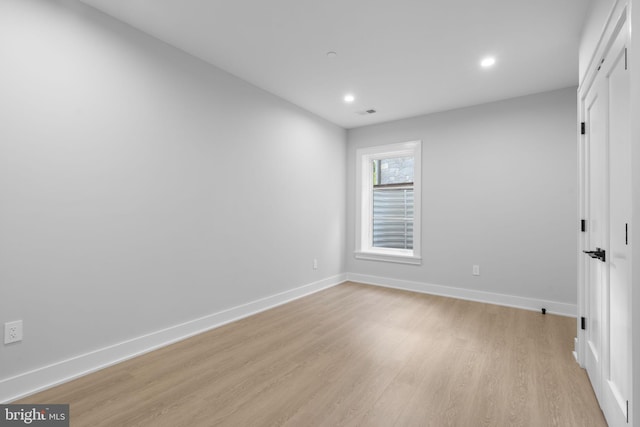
left=347, top=273, right=578, bottom=317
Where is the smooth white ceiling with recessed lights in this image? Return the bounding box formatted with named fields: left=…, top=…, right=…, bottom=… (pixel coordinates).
left=81, top=0, right=589, bottom=128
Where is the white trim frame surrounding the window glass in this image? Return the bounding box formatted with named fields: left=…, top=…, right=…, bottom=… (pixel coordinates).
left=355, top=141, right=422, bottom=265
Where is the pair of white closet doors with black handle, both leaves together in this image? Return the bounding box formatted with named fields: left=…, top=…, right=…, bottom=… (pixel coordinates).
left=583, top=15, right=631, bottom=426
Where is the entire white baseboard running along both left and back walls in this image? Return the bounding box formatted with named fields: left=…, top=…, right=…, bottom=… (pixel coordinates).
left=0, top=273, right=577, bottom=403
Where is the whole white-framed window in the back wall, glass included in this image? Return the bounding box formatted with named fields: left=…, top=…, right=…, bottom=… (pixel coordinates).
left=356, top=141, right=421, bottom=264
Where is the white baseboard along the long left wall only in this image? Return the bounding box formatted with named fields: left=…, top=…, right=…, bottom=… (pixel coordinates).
left=0, top=274, right=346, bottom=403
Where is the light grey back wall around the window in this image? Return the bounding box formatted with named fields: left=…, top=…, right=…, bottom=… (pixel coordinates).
left=346, top=88, right=577, bottom=314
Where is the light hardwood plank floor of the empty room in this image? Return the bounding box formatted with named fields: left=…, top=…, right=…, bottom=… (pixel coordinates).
left=17, top=283, right=606, bottom=427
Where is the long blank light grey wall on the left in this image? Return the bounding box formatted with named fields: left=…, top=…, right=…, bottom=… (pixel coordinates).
left=0, top=0, right=346, bottom=401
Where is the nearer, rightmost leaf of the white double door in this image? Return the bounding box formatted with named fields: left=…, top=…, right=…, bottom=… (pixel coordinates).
left=600, top=25, right=631, bottom=426
